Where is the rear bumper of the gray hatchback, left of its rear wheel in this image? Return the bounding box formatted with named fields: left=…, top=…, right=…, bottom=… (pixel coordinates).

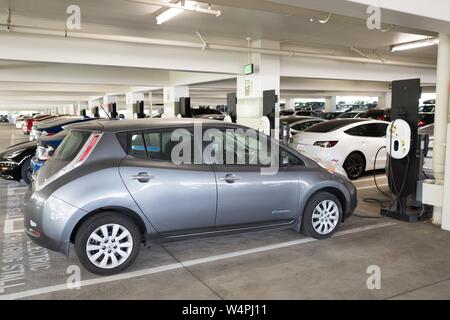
left=22, top=187, right=84, bottom=255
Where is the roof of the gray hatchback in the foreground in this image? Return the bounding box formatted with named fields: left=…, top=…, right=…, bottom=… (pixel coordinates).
left=64, top=118, right=246, bottom=132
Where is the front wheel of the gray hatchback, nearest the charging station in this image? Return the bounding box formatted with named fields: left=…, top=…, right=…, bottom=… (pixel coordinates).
left=302, top=191, right=343, bottom=240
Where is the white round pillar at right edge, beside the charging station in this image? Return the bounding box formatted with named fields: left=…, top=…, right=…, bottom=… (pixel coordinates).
left=433, top=33, right=450, bottom=226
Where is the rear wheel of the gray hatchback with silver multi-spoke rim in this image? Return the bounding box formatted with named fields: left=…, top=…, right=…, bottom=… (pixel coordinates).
left=75, top=212, right=142, bottom=276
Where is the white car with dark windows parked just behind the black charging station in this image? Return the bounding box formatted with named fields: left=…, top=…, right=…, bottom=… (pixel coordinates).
left=290, top=119, right=389, bottom=179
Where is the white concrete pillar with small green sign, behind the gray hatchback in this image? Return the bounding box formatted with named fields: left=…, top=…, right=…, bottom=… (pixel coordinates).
left=236, top=40, right=280, bottom=129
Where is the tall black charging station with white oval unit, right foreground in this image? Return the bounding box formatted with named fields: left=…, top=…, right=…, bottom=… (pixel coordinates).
left=381, top=79, right=429, bottom=222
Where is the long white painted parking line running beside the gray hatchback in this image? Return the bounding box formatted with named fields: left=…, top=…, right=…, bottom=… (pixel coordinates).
left=0, top=222, right=397, bottom=300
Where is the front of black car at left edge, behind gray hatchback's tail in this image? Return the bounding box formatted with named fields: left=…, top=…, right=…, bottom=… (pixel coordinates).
left=0, top=141, right=37, bottom=184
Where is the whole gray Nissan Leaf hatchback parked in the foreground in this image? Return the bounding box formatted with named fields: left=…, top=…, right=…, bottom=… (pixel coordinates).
left=23, top=119, right=357, bottom=275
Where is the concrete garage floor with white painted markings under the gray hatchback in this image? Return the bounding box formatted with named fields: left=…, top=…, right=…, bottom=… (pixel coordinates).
left=0, top=124, right=450, bottom=299
